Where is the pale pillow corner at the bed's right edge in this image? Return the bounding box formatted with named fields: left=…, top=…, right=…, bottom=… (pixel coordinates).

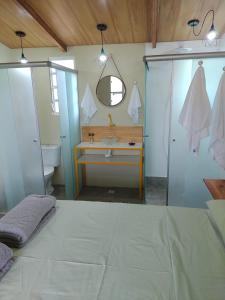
left=207, top=199, right=225, bottom=243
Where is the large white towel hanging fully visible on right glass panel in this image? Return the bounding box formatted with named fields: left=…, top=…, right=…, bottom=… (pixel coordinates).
left=179, top=66, right=211, bottom=154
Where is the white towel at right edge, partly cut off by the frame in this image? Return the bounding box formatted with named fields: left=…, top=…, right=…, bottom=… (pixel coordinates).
left=209, top=72, right=225, bottom=169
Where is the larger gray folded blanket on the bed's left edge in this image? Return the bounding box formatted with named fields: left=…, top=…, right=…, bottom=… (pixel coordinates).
left=0, top=195, right=56, bottom=248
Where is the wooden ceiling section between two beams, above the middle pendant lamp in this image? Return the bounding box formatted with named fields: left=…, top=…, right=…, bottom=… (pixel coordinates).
left=21, top=0, right=147, bottom=46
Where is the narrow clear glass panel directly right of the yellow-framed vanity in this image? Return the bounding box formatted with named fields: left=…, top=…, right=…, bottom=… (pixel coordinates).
left=144, top=61, right=172, bottom=205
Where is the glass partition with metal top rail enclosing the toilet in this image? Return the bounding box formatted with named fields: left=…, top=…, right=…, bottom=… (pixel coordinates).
left=0, top=61, right=80, bottom=211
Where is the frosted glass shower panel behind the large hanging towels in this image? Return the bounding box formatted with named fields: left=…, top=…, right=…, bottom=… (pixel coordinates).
left=168, top=58, right=225, bottom=207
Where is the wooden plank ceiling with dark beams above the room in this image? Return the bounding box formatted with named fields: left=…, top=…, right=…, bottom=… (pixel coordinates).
left=0, top=0, right=225, bottom=50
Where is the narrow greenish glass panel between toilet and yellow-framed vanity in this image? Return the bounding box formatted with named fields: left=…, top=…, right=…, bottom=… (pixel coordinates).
left=56, top=70, right=80, bottom=199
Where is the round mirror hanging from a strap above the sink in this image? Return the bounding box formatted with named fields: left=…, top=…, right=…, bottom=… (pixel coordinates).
left=96, top=75, right=126, bottom=106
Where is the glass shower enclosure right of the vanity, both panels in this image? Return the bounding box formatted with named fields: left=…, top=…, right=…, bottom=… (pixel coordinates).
left=145, top=56, right=225, bottom=207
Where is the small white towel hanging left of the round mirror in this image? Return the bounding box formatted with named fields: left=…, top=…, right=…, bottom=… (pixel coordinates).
left=80, top=84, right=97, bottom=124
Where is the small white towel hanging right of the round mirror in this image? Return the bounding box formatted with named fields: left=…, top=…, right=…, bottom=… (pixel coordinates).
left=128, top=84, right=141, bottom=124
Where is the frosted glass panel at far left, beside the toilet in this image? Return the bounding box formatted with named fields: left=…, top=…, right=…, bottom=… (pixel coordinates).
left=0, top=68, right=45, bottom=210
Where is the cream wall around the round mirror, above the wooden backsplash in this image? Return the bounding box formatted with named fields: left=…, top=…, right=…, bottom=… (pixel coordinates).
left=10, top=44, right=145, bottom=125
